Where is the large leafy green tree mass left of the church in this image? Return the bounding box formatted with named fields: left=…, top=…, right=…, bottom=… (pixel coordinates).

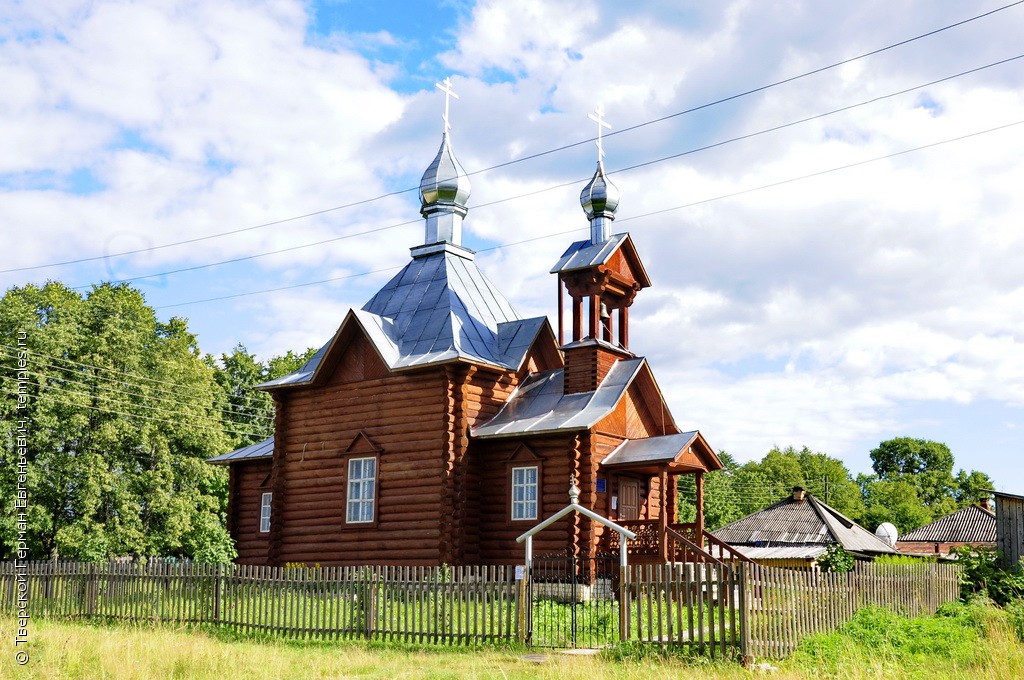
left=0, top=283, right=233, bottom=560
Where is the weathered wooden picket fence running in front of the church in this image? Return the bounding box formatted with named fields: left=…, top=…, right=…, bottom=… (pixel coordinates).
left=0, top=561, right=962, bottom=658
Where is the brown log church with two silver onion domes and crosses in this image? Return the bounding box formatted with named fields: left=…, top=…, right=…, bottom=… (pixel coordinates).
left=210, top=93, right=724, bottom=565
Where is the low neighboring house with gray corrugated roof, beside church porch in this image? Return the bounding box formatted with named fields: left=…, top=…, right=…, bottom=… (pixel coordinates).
left=713, top=486, right=896, bottom=569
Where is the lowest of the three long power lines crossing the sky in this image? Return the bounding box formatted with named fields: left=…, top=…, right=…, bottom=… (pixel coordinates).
left=154, top=116, right=1024, bottom=309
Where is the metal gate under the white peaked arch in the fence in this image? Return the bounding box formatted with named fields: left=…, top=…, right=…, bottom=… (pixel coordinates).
left=526, top=555, right=620, bottom=648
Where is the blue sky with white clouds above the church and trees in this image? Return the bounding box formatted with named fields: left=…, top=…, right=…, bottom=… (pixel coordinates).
left=0, top=0, right=1024, bottom=494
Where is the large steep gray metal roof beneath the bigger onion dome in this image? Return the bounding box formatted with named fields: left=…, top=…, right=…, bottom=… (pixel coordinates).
left=258, top=246, right=554, bottom=389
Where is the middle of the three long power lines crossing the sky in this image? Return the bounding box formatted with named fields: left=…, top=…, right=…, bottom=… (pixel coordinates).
left=71, top=53, right=1024, bottom=290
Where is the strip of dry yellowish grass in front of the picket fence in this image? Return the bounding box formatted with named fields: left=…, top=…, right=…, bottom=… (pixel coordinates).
left=0, top=619, right=1024, bottom=680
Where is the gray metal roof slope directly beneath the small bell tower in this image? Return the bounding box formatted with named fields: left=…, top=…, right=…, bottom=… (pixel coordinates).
left=472, top=357, right=638, bottom=438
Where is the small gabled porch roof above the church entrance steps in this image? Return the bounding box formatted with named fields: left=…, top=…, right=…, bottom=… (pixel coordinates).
left=601, top=430, right=722, bottom=474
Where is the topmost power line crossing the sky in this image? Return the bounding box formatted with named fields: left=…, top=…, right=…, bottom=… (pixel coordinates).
left=0, top=0, right=1024, bottom=273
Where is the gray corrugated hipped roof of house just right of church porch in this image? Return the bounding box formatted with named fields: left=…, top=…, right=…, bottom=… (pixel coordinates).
left=712, top=494, right=896, bottom=555
